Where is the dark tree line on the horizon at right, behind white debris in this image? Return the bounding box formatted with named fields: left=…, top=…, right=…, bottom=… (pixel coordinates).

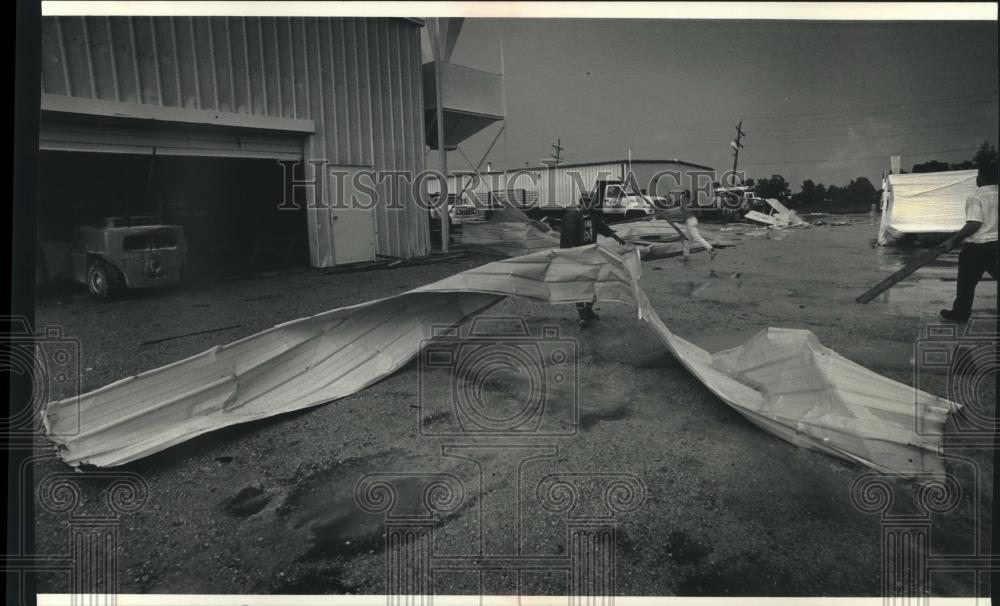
left=743, top=141, right=997, bottom=213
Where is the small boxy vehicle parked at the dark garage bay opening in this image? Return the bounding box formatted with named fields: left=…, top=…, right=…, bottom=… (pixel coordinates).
left=36, top=217, right=187, bottom=299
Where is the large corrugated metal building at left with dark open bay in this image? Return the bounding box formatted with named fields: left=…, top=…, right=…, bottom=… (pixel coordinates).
left=39, top=17, right=430, bottom=267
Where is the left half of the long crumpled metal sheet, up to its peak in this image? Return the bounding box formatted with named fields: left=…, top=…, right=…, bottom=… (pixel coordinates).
left=43, top=246, right=638, bottom=467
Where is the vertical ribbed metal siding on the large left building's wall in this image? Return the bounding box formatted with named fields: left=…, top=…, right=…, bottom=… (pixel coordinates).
left=41, top=17, right=430, bottom=265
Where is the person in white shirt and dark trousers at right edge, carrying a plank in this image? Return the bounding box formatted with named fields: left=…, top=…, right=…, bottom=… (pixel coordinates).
left=941, top=159, right=1000, bottom=322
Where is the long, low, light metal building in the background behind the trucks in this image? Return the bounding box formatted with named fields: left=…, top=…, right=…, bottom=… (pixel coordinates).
left=428, top=160, right=715, bottom=207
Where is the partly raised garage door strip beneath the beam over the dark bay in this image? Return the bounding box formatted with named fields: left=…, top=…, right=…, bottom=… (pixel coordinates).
left=39, top=117, right=302, bottom=160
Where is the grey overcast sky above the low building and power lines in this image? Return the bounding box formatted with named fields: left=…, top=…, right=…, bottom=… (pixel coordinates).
left=436, top=19, right=998, bottom=191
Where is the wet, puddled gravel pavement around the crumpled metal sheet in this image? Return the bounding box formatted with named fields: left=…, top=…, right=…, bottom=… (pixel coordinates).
left=35, top=215, right=997, bottom=596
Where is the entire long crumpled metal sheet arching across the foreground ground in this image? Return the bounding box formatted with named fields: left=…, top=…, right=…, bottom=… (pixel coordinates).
left=43, top=245, right=957, bottom=476
